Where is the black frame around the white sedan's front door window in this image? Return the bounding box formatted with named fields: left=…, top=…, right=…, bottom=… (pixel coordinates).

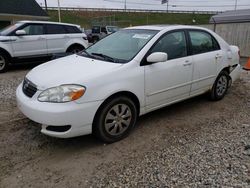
left=140, top=29, right=189, bottom=66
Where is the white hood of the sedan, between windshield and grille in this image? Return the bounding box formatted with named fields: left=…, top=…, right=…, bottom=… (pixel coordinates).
left=26, top=55, right=122, bottom=90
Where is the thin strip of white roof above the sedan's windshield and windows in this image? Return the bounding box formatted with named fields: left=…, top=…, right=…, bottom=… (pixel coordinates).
left=126, top=25, right=210, bottom=31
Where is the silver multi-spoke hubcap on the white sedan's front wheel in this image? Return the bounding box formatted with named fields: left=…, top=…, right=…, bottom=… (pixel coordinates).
left=105, top=104, right=132, bottom=136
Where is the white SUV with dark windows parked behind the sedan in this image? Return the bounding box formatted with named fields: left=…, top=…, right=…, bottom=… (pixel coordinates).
left=0, top=21, right=88, bottom=73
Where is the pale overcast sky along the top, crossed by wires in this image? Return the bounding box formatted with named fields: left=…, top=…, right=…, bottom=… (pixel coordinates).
left=36, top=0, right=250, bottom=11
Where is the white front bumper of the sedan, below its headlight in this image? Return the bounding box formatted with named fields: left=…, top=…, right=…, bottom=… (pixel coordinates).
left=16, top=84, right=103, bottom=138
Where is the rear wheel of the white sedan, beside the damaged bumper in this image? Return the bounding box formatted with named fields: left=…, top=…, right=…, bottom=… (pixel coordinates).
left=210, top=71, right=230, bottom=101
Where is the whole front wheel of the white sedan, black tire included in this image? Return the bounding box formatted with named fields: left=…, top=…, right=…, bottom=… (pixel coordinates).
left=93, top=96, right=137, bottom=143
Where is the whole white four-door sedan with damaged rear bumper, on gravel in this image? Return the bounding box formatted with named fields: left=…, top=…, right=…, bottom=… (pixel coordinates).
left=16, top=25, right=240, bottom=143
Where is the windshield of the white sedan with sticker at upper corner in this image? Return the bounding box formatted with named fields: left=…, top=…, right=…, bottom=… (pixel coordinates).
left=82, top=29, right=158, bottom=63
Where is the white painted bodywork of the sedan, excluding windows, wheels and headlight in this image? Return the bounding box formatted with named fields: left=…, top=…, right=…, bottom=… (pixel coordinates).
left=17, top=26, right=240, bottom=138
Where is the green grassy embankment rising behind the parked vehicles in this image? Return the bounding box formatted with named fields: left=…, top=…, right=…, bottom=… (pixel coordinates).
left=48, top=10, right=212, bottom=28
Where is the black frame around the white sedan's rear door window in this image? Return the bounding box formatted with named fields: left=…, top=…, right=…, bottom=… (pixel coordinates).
left=186, top=29, right=221, bottom=55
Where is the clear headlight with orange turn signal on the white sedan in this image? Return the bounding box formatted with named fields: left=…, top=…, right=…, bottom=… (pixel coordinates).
left=38, top=85, right=86, bottom=103
